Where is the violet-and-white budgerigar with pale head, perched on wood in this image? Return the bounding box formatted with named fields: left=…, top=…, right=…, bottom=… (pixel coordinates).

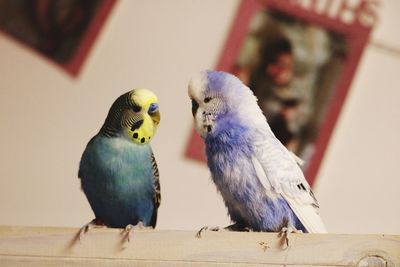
left=189, top=71, right=326, bottom=241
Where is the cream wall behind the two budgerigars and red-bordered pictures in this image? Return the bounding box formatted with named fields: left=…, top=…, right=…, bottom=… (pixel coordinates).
left=0, top=0, right=400, bottom=234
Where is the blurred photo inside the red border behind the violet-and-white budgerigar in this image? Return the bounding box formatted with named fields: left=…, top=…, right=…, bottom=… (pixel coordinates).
left=233, top=11, right=347, bottom=165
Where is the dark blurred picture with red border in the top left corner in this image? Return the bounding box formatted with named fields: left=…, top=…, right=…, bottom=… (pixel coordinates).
left=0, top=0, right=115, bottom=76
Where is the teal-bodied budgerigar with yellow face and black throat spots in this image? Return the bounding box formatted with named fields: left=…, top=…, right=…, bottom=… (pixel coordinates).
left=78, top=89, right=161, bottom=237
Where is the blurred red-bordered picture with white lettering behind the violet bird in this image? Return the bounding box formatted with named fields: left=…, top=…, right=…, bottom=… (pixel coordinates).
left=186, top=0, right=377, bottom=184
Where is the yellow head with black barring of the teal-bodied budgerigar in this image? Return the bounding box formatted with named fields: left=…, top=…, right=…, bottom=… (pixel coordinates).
left=100, top=89, right=160, bottom=144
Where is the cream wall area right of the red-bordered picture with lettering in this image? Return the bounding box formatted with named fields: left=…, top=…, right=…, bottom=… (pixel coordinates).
left=315, top=0, right=400, bottom=234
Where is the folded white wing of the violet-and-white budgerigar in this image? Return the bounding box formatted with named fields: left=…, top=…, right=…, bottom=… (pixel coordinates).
left=252, top=128, right=326, bottom=233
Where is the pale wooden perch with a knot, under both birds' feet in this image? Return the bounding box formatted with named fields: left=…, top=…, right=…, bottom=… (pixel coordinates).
left=0, top=226, right=400, bottom=267
